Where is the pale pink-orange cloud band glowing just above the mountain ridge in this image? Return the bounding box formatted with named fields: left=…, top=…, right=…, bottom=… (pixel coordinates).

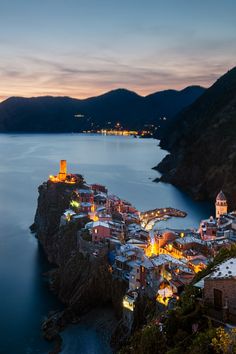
left=0, top=41, right=235, bottom=98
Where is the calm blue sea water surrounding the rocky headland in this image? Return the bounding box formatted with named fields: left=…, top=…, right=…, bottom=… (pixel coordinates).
left=0, top=134, right=212, bottom=354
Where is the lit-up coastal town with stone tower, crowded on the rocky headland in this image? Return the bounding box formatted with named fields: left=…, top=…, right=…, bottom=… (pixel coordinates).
left=47, top=160, right=236, bottom=328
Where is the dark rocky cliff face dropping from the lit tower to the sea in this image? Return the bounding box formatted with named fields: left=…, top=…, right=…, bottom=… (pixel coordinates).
left=31, top=181, right=126, bottom=348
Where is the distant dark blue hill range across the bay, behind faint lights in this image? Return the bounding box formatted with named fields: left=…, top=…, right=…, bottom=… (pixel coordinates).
left=0, top=86, right=205, bottom=132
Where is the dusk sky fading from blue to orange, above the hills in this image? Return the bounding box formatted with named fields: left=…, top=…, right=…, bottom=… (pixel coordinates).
left=0, top=0, right=236, bottom=101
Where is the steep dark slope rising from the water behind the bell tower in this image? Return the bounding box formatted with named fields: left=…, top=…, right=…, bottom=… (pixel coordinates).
left=157, top=68, right=236, bottom=208
